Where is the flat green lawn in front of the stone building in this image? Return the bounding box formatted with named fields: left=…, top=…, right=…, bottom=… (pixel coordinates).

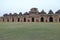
left=0, top=23, right=60, bottom=40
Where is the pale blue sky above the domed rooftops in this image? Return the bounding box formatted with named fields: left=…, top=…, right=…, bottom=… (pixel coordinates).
left=0, top=0, right=60, bottom=16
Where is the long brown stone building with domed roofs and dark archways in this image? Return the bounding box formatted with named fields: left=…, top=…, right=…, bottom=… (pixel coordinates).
left=0, top=8, right=60, bottom=22
